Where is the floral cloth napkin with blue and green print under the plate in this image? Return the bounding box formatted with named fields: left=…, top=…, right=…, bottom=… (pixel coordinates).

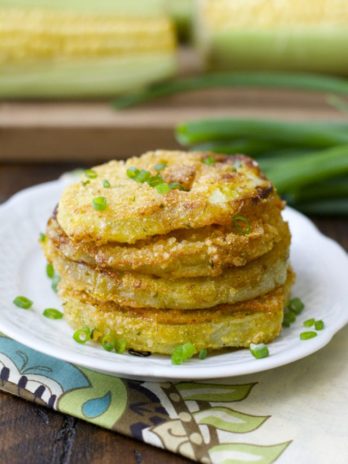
left=0, top=327, right=348, bottom=464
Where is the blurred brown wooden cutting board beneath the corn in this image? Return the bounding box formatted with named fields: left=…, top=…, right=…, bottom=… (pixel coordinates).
left=0, top=51, right=347, bottom=164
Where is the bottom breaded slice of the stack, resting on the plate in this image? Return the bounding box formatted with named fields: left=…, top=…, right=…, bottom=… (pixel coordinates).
left=60, top=271, right=293, bottom=354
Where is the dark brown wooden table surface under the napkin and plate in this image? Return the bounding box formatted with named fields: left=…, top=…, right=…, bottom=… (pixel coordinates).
left=0, top=163, right=348, bottom=464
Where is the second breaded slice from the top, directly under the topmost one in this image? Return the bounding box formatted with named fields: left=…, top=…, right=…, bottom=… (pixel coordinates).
left=47, top=202, right=289, bottom=278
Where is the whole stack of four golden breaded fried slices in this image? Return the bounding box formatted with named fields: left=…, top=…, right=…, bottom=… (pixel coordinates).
left=44, top=150, right=294, bottom=354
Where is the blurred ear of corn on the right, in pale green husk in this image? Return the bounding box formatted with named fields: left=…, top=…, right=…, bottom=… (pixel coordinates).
left=195, top=0, right=348, bottom=74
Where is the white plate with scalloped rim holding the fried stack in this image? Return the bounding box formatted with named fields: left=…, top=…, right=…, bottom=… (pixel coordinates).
left=0, top=180, right=348, bottom=379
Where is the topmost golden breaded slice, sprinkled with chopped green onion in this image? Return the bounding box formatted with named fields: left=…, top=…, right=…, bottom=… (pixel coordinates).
left=57, top=151, right=275, bottom=246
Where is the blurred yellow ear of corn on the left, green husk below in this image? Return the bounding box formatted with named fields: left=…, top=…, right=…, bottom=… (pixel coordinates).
left=0, top=0, right=176, bottom=98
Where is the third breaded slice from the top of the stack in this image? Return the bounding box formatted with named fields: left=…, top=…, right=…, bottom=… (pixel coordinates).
left=45, top=233, right=290, bottom=310
